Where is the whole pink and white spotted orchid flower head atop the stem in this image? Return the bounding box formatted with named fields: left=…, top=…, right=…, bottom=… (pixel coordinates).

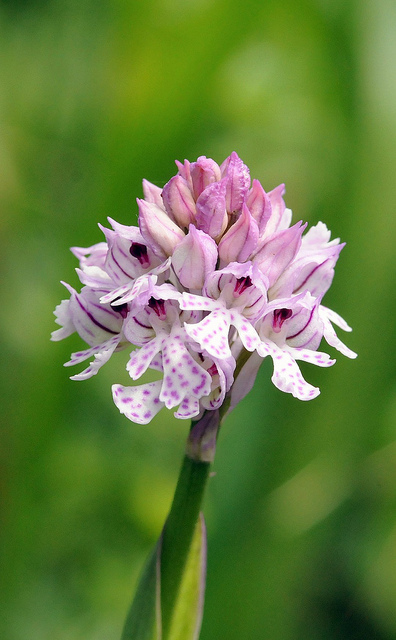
left=52, top=152, right=356, bottom=424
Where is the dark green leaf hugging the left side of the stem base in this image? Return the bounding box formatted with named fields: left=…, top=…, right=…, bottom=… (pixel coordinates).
left=121, top=536, right=162, bottom=640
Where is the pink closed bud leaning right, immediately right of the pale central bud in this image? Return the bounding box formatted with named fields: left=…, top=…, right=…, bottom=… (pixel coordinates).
left=219, top=204, right=259, bottom=266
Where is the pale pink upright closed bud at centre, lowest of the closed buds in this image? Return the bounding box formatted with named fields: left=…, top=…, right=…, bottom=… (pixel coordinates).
left=172, top=224, right=217, bottom=289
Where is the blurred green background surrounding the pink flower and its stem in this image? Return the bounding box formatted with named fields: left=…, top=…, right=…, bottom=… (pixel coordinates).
left=0, top=0, right=396, bottom=640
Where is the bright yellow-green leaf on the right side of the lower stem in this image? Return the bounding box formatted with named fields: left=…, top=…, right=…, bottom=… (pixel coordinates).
left=164, top=513, right=206, bottom=640
